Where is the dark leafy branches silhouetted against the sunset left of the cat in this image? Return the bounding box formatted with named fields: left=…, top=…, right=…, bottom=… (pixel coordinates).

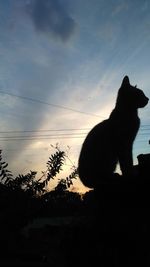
left=0, top=145, right=78, bottom=196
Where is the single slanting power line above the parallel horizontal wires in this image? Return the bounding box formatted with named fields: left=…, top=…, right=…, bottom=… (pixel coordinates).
left=0, top=91, right=104, bottom=118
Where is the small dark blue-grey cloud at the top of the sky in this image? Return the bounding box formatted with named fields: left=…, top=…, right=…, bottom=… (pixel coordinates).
left=27, top=0, right=76, bottom=41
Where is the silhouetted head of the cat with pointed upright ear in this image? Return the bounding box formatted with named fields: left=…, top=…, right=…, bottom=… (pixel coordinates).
left=116, top=76, right=149, bottom=109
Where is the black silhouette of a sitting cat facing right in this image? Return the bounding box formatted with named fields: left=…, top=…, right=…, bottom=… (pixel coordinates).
left=78, top=76, right=149, bottom=188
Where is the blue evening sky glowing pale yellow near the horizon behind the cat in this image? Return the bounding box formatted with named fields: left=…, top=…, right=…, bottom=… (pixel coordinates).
left=0, top=0, right=150, bottom=194
